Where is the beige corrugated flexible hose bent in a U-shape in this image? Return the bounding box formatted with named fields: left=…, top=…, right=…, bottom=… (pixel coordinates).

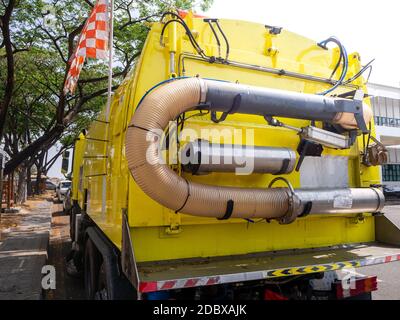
left=126, top=78, right=383, bottom=223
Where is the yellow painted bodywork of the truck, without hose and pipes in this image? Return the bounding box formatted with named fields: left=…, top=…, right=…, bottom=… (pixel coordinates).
left=72, top=14, right=400, bottom=296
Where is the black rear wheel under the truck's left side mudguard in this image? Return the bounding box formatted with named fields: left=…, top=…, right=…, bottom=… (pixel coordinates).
left=84, top=239, right=101, bottom=300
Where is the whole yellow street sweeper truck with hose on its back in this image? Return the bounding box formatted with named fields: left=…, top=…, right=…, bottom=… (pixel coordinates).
left=64, top=12, right=400, bottom=299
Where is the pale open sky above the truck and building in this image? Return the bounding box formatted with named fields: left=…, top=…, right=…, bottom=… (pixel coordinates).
left=205, top=0, right=400, bottom=87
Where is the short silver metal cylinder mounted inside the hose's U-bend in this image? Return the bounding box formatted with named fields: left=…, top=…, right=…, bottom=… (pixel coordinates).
left=181, top=139, right=296, bottom=174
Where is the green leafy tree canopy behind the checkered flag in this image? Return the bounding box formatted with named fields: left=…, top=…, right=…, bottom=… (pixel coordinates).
left=0, top=0, right=212, bottom=178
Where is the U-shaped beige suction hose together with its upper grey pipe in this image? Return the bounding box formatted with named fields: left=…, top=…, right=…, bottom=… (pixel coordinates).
left=126, top=78, right=383, bottom=223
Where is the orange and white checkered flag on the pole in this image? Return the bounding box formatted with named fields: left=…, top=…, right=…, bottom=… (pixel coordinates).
left=64, top=0, right=110, bottom=94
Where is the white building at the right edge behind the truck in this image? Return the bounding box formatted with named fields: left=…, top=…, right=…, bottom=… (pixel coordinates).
left=368, top=83, right=400, bottom=186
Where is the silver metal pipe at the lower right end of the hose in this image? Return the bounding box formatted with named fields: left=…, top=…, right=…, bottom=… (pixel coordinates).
left=295, top=188, right=385, bottom=214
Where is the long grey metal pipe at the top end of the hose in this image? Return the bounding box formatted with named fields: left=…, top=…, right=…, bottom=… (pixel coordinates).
left=202, top=80, right=372, bottom=130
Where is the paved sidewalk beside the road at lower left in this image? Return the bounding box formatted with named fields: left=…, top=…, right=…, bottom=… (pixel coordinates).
left=0, top=198, right=52, bottom=300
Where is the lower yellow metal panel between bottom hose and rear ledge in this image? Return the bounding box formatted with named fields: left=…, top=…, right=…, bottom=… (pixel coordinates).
left=132, top=217, right=374, bottom=261
